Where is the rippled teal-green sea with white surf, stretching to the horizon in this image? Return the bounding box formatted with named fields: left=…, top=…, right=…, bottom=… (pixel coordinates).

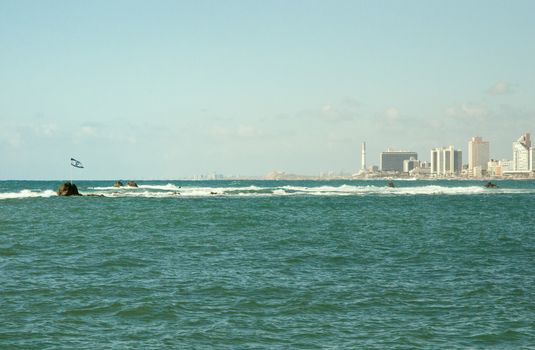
left=0, top=180, right=535, bottom=349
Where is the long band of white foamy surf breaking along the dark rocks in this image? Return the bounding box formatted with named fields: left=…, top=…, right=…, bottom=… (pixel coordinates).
left=0, top=183, right=535, bottom=199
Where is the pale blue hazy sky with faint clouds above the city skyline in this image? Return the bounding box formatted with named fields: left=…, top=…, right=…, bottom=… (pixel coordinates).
left=0, top=0, right=535, bottom=180
